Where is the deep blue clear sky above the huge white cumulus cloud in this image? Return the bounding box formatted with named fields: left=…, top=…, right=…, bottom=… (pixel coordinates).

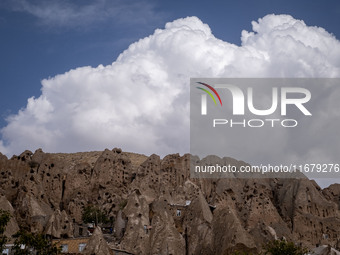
left=0, top=0, right=340, bottom=127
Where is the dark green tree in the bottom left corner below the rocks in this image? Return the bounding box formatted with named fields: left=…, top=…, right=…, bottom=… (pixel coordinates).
left=13, top=230, right=60, bottom=255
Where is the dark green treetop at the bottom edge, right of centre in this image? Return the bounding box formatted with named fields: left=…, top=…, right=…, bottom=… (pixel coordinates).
left=263, top=240, right=308, bottom=255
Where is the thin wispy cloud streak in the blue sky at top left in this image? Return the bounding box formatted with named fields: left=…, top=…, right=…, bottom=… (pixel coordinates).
left=7, top=0, right=155, bottom=29
